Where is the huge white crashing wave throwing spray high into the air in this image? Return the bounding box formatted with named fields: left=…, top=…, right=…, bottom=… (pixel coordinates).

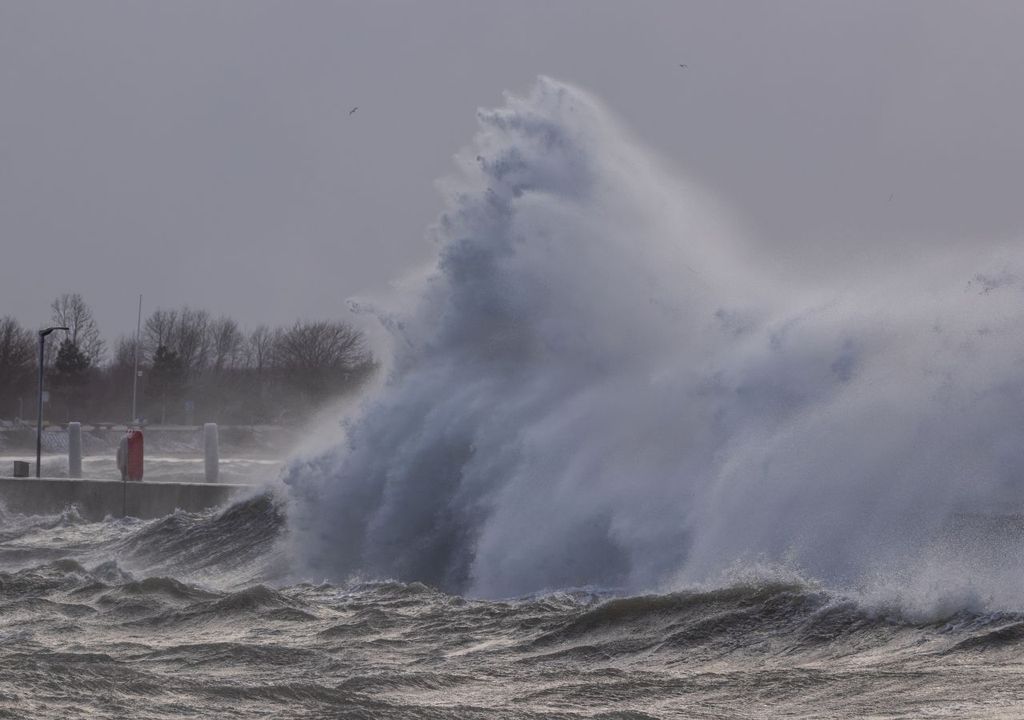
left=286, top=78, right=1024, bottom=605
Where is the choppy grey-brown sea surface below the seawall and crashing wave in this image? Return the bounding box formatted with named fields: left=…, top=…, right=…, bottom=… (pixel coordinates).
left=0, top=495, right=1024, bottom=718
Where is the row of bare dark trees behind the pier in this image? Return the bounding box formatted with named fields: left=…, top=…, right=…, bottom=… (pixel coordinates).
left=0, top=293, right=377, bottom=424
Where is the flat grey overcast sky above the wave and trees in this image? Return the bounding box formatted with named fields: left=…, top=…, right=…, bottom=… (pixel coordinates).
left=0, top=0, right=1024, bottom=339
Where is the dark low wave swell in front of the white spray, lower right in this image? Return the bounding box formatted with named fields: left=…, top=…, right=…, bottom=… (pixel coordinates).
left=523, top=583, right=1024, bottom=659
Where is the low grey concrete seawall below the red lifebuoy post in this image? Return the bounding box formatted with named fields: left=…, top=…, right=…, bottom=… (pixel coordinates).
left=0, top=477, right=259, bottom=520
